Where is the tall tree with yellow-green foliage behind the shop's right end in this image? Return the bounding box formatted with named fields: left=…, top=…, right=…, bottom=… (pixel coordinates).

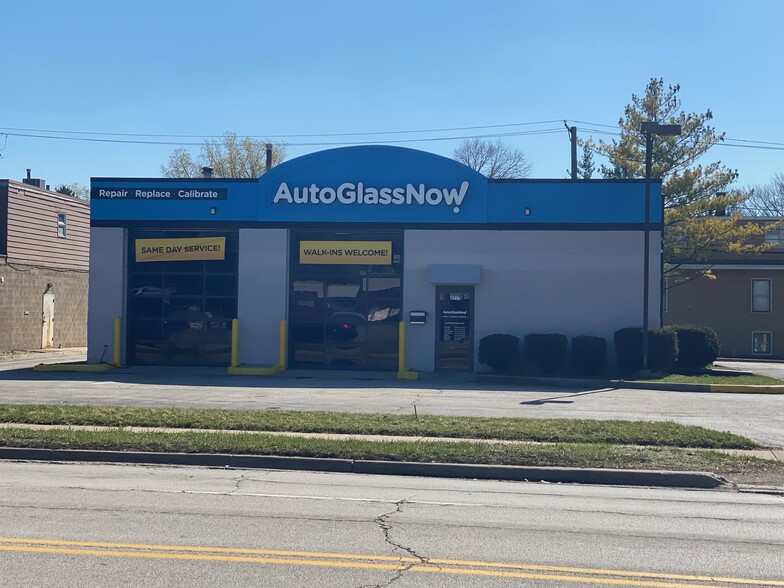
left=585, top=78, right=763, bottom=286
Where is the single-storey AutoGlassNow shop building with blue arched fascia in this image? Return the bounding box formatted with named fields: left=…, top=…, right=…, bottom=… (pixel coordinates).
left=88, top=146, right=661, bottom=372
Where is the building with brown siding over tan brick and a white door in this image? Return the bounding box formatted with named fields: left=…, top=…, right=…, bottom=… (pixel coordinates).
left=0, top=170, right=90, bottom=351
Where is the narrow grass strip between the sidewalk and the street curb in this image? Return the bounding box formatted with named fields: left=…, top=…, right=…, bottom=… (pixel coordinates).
left=0, top=429, right=784, bottom=473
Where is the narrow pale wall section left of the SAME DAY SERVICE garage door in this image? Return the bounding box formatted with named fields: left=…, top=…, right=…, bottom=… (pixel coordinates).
left=87, top=227, right=127, bottom=363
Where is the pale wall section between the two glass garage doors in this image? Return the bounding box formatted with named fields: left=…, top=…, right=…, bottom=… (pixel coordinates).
left=237, top=229, right=289, bottom=365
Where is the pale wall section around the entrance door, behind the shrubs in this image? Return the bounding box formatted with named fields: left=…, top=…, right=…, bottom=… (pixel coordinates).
left=403, top=230, right=660, bottom=371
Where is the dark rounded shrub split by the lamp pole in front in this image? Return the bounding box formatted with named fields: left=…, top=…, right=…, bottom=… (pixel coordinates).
left=613, top=327, right=678, bottom=374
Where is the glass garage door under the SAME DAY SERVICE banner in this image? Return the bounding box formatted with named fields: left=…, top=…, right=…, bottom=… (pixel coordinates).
left=127, top=231, right=239, bottom=366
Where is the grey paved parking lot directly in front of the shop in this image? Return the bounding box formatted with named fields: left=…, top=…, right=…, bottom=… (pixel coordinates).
left=0, top=359, right=784, bottom=447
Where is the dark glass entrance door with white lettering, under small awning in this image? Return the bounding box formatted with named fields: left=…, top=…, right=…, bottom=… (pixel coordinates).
left=436, top=286, right=474, bottom=371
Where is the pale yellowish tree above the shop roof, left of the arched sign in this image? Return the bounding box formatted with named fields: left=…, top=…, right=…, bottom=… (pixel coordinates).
left=161, top=132, right=286, bottom=178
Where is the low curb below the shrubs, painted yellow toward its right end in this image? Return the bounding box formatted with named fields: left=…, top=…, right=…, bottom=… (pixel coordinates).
left=476, top=374, right=784, bottom=394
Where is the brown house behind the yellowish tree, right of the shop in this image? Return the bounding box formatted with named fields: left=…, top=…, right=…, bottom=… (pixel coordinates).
left=663, top=218, right=784, bottom=359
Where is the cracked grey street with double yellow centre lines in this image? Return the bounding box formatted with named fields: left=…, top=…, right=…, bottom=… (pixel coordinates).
left=0, top=462, right=784, bottom=588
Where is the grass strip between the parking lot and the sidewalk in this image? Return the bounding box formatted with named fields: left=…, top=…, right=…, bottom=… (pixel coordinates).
left=0, top=404, right=759, bottom=449
